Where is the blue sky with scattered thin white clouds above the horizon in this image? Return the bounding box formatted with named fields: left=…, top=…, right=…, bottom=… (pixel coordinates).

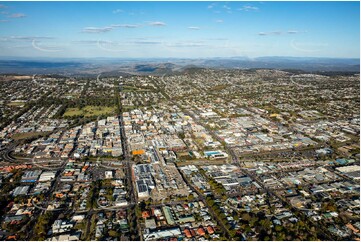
left=0, top=1, right=360, bottom=58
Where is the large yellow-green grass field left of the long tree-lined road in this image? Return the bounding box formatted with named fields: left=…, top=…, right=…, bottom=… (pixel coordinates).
left=63, top=106, right=116, bottom=117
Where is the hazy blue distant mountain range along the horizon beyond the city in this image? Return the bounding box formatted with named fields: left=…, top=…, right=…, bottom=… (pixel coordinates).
left=0, top=57, right=360, bottom=75
